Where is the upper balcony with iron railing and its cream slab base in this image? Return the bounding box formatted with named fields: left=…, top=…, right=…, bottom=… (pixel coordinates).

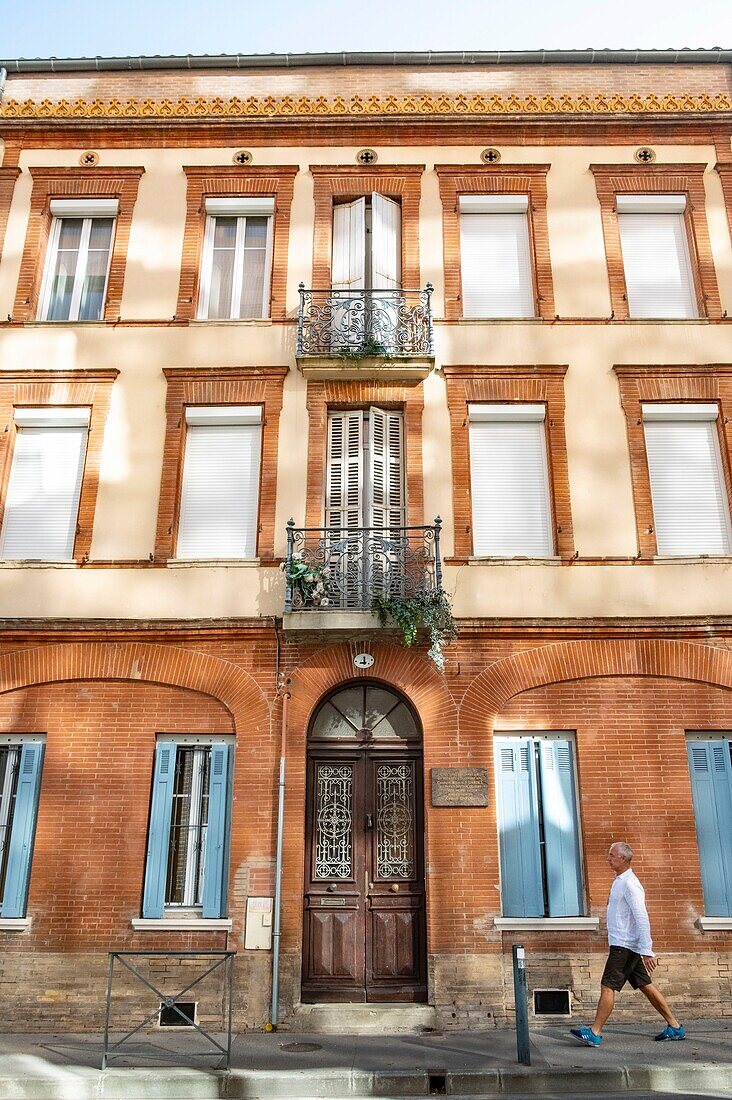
left=297, top=283, right=435, bottom=381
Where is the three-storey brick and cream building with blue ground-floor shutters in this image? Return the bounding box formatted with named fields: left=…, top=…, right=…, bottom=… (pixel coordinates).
left=0, top=51, right=732, bottom=1030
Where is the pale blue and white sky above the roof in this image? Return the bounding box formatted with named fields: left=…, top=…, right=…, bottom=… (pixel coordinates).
left=0, top=0, right=732, bottom=59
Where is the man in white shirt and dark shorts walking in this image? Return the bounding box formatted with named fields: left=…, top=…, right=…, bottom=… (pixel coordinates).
left=571, top=844, right=686, bottom=1046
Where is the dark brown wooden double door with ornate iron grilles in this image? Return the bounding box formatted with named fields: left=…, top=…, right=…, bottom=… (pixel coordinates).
left=302, top=741, right=427, bottom=1003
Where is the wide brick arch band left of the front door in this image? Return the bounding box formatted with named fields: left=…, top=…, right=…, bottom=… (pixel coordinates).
left=0, top=641, right=270, bottom=737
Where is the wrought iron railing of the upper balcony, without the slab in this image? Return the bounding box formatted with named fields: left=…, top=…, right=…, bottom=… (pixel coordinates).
left=297, top=283, right=435, bottom=359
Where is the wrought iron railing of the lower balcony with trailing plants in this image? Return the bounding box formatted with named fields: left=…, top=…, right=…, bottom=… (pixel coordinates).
left=285, top=516, right=443, bottom=612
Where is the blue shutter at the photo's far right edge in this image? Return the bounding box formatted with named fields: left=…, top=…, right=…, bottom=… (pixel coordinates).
left=687, top=739, right=732, bottom=916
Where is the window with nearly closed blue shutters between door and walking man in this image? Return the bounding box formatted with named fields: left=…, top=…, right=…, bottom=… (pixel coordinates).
left=494, top=734, right=584, bottom=917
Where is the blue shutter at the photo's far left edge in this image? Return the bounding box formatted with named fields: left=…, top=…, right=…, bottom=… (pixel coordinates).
left=0, top=741, right=43, bottom=917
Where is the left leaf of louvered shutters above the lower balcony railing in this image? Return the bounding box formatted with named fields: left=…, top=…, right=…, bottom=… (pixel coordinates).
left=326, top=409, right=363, bottom=528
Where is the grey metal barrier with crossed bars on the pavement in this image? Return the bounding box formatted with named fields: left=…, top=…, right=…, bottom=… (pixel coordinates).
left=101, top=952, right=237, bottom=1069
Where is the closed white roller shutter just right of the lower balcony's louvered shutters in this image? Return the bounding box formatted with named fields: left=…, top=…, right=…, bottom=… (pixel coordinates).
left=469, top=405, right=554, bottom=558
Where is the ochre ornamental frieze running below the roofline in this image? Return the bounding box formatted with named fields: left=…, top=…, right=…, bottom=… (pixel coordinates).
left=0, top=94, right=732, bottom=120
